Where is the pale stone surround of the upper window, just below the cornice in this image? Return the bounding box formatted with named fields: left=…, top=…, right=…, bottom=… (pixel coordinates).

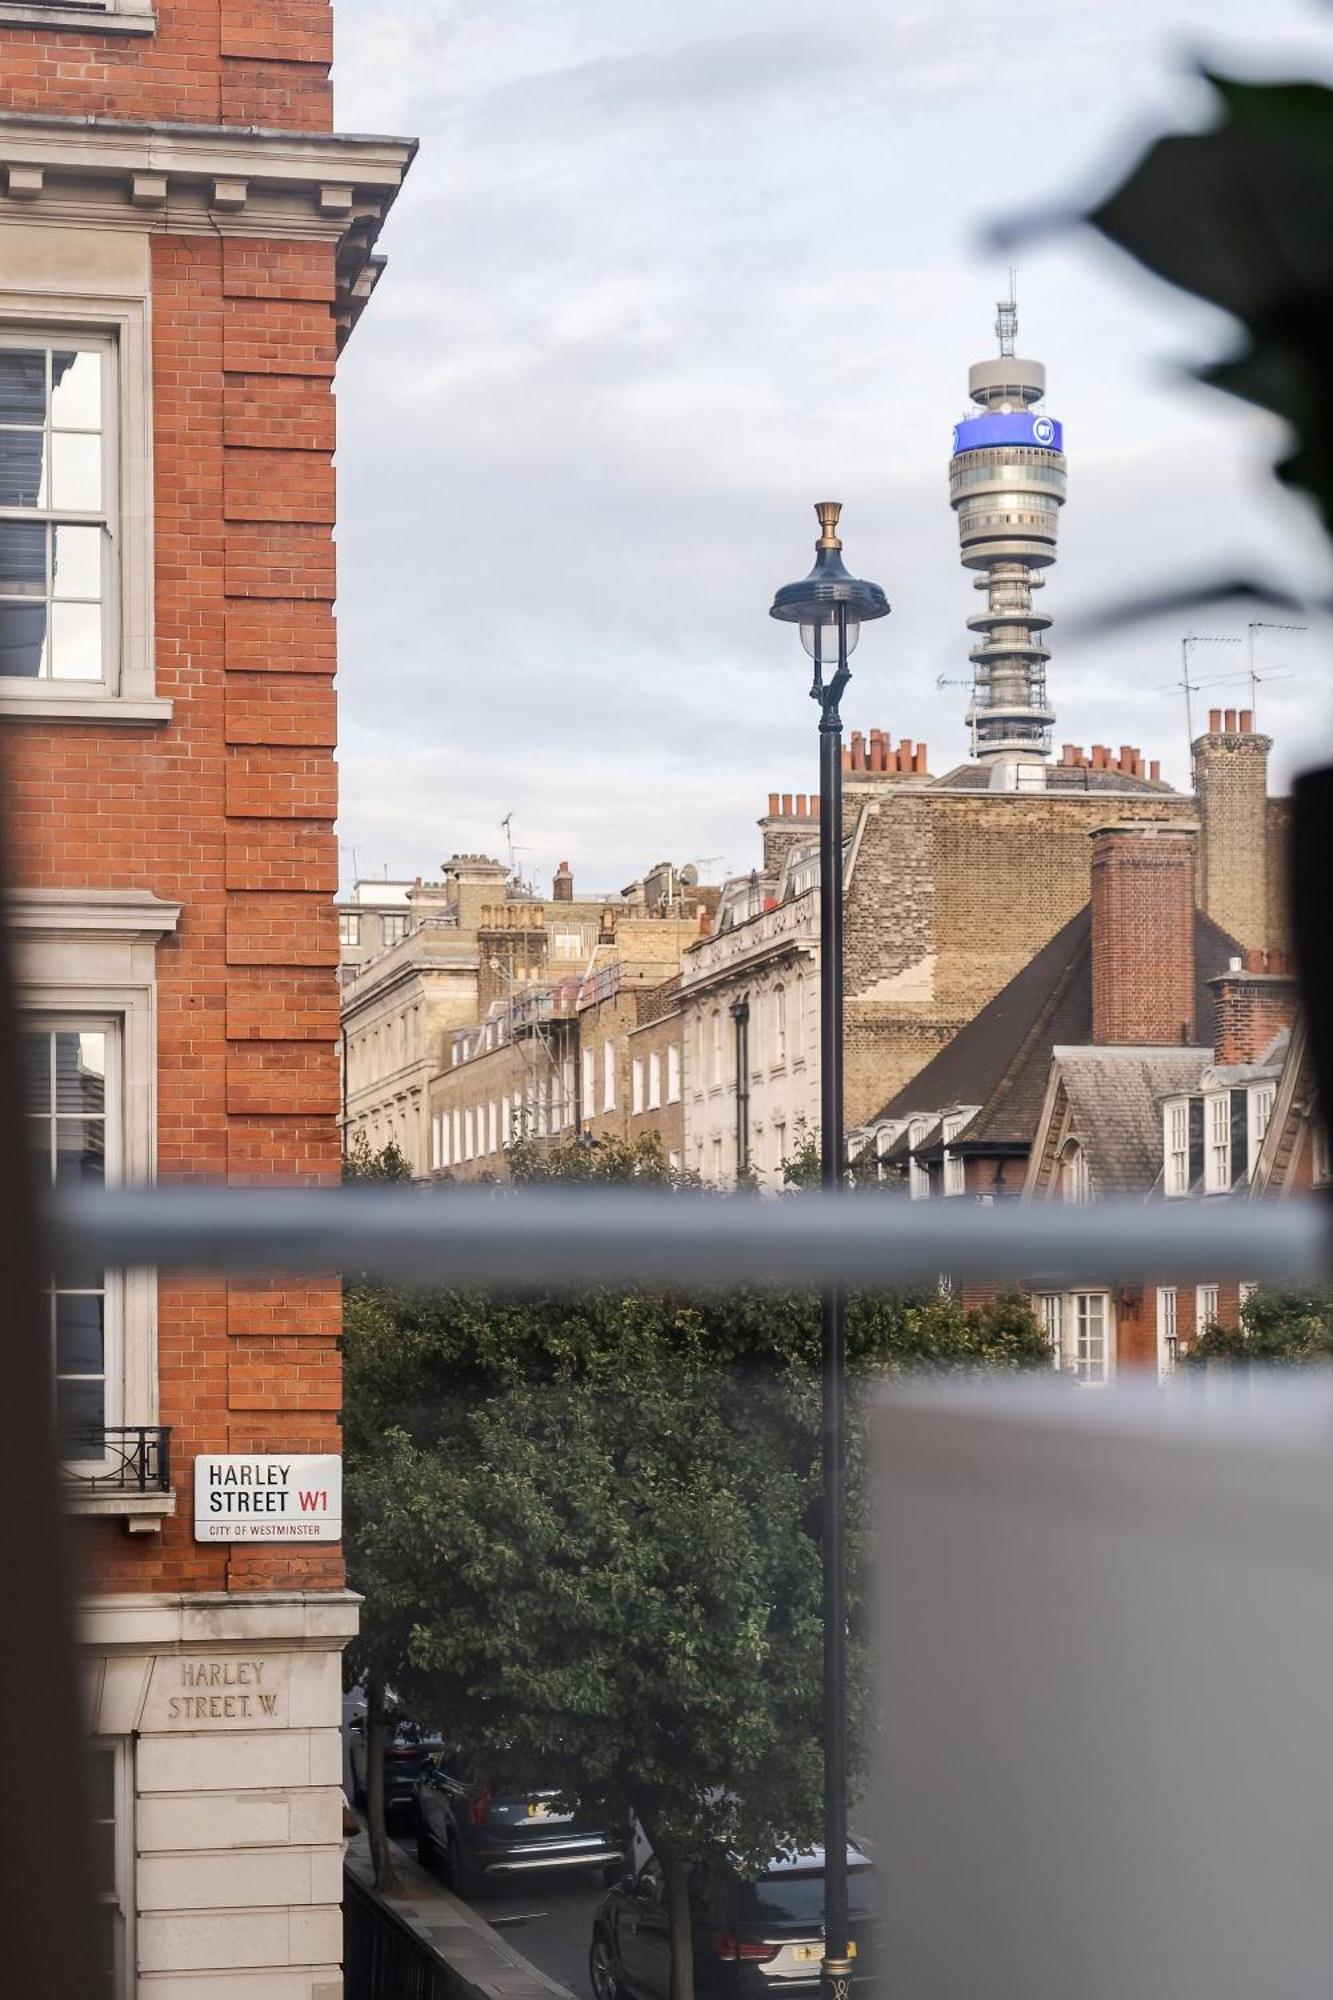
left=0, top=278, right=160, bottom=724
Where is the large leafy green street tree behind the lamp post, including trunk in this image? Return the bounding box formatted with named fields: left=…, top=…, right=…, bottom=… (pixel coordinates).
left=344, top=1146, right=1049, bottom=1996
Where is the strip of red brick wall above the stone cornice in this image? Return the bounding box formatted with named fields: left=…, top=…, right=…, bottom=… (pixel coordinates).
left=4, top=0, right=332, bottom=132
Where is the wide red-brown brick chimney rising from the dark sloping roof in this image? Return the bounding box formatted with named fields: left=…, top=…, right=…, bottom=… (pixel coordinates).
left=1093, top=820, right=1199, bottom=1048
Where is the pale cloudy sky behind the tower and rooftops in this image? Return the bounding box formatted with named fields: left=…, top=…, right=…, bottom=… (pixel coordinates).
left=326, top=0, right=1333, bottom=890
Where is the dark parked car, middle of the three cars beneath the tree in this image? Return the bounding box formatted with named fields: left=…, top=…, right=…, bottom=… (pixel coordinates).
left=416, top=1748, right=632, bottom=1896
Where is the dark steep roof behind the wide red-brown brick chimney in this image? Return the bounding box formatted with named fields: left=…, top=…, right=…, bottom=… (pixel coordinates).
left=869, top=904, right=1241, bottom=1150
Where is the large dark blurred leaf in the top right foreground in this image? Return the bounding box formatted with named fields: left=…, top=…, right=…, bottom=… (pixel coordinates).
left=1089, top=72, right=1333, bottom=548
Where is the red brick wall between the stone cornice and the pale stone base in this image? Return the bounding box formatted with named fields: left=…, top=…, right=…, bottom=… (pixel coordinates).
left=4, top=223, right=342, bottom=1590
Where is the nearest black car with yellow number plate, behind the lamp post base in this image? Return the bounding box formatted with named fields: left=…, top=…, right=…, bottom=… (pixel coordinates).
left=588, top=1846, right=875, bottom=2000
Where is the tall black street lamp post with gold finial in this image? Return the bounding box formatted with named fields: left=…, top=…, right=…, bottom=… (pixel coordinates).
left=771, top=500, right=889, bottom=2000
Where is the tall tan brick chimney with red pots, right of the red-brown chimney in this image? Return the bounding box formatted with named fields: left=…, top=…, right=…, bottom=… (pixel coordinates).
left=1193, top=708, right=1283, bottom=952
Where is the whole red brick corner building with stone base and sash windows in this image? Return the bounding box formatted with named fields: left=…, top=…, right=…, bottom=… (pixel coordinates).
left=0, top=0, right=412, bottom=2000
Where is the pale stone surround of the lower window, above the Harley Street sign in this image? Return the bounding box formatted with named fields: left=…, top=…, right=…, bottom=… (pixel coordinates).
left=10, top=890, right=180, bottom=1488
